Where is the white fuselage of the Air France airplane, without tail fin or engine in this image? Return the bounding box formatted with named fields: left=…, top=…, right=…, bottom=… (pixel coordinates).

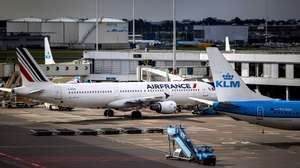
left=15, top=82, right=216, bottom=108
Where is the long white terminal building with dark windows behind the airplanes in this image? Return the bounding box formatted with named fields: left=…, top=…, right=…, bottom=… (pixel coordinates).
left=83, top=51, right=300, bottom=100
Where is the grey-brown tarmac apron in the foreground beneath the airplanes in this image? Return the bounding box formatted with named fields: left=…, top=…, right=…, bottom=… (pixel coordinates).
left=0, top=108, right=300, bottom=168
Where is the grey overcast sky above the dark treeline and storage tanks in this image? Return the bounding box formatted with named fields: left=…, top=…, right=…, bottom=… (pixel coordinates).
left=0, top=0, right=300, bottom=21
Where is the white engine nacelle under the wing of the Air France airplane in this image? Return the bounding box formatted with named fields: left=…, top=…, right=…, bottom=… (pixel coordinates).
left=150, top=101, right=177, bottom=114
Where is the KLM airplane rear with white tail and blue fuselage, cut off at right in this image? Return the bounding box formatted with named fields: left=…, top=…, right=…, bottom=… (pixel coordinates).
left=190, top=47, right=300, bottom=130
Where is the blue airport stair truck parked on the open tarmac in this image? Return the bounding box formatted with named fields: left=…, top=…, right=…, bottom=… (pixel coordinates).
left=166, top=125, right=216, bottom=166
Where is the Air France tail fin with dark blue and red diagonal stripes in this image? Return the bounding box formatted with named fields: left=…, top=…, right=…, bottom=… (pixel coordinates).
left=17, top=48, right=49, bottom=85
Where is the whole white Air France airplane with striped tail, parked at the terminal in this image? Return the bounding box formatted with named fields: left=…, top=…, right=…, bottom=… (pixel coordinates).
left=0, top=48, right=216, bottom=118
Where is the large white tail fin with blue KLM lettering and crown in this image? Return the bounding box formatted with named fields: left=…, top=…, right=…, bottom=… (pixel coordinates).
left=206, top=47, right=270, bottom=102
